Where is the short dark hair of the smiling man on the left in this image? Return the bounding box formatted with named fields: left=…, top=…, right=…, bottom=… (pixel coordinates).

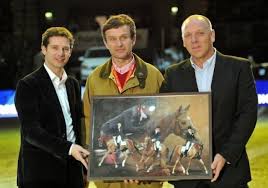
left=41, top=27, right=74, bottom=49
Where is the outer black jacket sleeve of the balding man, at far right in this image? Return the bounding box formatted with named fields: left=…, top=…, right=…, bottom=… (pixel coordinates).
left=220, top=62, right=258, bottom=165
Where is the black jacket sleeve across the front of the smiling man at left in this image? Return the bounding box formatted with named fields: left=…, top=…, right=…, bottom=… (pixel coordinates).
left=15, top=80, right=72, bottom=158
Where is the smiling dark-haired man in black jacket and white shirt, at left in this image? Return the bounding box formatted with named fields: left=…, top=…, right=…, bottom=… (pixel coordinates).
left=15, top=27, right=89, bottom=188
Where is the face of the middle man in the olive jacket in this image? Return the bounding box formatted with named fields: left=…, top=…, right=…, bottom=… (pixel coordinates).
left=105, top=25, right=136, bottom=60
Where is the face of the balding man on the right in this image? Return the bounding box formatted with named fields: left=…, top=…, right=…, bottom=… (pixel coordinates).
left=182, top=19, right=215, bottom=61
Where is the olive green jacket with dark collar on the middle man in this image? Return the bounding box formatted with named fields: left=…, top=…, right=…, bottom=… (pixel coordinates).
left=82, top=54, right=164, bottom=188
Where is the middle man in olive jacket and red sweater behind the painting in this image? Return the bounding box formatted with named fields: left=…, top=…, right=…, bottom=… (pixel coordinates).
left=83, top=14, right=163, bottom=188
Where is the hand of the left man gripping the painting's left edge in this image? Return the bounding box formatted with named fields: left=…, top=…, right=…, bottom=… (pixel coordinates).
left=71, top=144, right=89, bottom=169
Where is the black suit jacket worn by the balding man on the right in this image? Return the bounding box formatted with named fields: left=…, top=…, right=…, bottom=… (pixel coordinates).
left=160, top=52, right=257, bottom=187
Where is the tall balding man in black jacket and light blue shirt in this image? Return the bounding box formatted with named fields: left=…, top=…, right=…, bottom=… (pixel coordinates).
left=161, top=15, right=257, bottom=188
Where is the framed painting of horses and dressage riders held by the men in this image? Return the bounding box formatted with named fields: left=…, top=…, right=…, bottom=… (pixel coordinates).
left=88, top=92, right=212, bottom=181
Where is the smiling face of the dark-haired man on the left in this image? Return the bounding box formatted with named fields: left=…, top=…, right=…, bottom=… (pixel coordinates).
left=42, top=36, right=71, bottom=70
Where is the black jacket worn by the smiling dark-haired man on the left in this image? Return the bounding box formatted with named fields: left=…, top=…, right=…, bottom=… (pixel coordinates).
left=15, top=66, right=82, bottom=185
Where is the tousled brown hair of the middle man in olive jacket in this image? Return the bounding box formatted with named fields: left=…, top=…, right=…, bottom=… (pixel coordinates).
left=102, top=14, right=136, bottom=41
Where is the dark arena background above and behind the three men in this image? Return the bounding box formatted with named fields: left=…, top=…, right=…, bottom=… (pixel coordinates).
left=0, top=0, right=268, bottom=89
